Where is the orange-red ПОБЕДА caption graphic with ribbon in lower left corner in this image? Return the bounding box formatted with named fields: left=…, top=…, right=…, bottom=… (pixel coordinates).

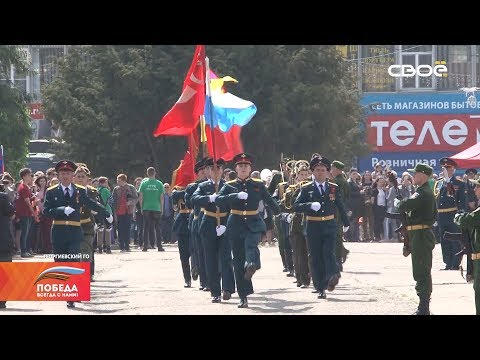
left=0, top=262, right=90, bottom=301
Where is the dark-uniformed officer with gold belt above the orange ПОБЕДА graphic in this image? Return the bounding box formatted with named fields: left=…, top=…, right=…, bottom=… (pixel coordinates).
left=43, top=160, right=113, bottom=308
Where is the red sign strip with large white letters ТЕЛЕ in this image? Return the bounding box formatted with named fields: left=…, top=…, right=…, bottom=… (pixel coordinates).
left=367, top=114, right=480, bottom=152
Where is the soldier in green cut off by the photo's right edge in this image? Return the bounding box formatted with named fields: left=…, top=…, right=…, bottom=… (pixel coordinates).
left=454, top=179, right=480, bottom=315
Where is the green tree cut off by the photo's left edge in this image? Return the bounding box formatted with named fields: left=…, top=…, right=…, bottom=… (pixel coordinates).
left=0, top=45, right=32, bottom=178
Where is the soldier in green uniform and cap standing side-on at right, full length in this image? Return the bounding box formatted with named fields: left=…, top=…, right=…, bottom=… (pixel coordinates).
left=394, top=164, right=437, bottom=315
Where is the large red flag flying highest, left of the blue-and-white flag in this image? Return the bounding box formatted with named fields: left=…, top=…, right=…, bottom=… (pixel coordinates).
left=153, top=45, right=205, bottom=136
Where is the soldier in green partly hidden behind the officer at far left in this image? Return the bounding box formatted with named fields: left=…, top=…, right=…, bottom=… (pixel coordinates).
left=73, top=166, right=98, bottom=281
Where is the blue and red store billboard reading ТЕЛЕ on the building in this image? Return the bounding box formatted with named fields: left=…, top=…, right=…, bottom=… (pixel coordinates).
left=359, top=91, right=480, bottom=171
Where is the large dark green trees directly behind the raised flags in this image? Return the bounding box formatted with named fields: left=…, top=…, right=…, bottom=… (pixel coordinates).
left=43, top=45, right=365, bottom=181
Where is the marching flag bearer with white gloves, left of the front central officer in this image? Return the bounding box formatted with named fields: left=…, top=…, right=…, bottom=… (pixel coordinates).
left=192, top=158, right=235, bottom=303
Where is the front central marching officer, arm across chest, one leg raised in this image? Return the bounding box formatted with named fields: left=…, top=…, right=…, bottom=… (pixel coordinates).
left=215, top=153, right=280, bottom=308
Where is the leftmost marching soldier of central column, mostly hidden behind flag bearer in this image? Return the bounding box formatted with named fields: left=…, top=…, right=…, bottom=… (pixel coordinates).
left=172, top=186, right=192, bottom=288
